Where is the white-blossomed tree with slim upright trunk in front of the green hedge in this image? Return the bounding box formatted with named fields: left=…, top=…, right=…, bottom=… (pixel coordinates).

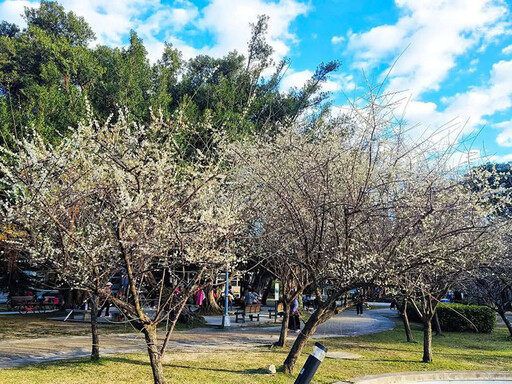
left=393, top=160, right=508, bottom=363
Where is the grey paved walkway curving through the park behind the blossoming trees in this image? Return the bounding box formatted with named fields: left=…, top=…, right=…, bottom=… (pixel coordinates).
left=0, top=309, right=396, bottom=368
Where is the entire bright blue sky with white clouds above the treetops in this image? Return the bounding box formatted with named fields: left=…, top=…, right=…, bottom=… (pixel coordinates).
left=0, top=0, right=512, bottom=161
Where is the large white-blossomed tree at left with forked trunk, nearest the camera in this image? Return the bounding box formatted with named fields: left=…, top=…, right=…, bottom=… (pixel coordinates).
left=1, top=107, right=237, bottom=383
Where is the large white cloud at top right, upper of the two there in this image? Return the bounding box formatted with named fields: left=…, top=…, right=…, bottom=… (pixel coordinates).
left=348, top=0, right=509, bottom=98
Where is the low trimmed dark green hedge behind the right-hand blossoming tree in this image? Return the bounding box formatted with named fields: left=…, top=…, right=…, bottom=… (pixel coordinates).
left=407, top=303, right=496, bottom=333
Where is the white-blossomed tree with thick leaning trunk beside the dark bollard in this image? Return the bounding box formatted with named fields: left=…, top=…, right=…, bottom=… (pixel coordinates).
left=229, top=101, right=408, bottom=372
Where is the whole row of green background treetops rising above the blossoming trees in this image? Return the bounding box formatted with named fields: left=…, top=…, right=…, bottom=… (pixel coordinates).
left=0, top=0, right=339, bottom=147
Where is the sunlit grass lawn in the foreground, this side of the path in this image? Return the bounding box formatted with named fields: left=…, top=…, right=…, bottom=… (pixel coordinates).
left=0, top=324, right=512, bottom=384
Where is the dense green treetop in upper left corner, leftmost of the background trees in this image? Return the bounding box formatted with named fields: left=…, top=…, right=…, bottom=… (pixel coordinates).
left=0, top=1, right=102, bottom=145
